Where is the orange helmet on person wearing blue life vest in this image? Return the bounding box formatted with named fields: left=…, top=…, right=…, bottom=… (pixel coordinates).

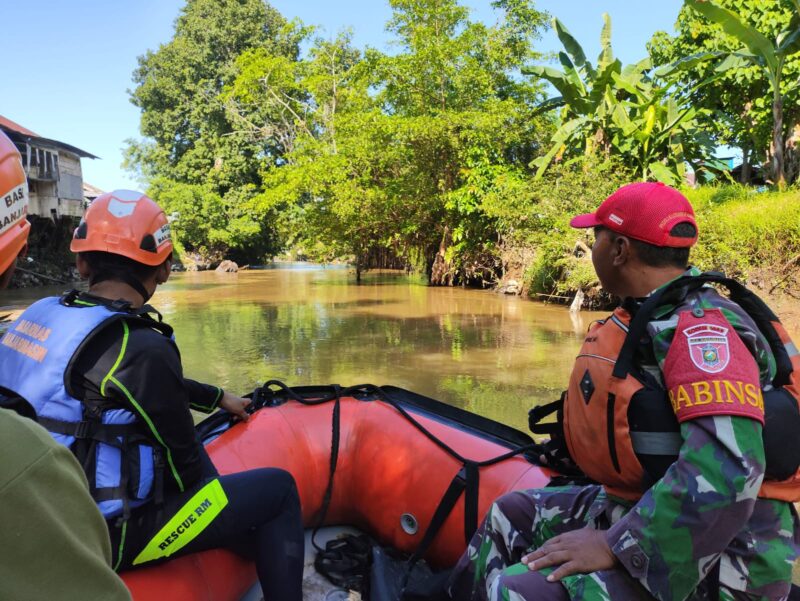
left=69, top=190, right=172, bottom=266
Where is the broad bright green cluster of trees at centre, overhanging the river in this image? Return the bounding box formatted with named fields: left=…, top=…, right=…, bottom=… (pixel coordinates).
left=229, top=0, right=546, bottom=283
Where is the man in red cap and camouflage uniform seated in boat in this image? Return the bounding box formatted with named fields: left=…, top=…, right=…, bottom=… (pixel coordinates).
left=449, top=183, right=800, bottom=601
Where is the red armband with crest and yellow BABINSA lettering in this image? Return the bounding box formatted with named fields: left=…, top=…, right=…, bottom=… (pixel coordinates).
left=664, top=309, right=764, bottom=423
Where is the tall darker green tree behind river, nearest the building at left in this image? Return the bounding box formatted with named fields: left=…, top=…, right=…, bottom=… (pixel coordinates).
left=126, top=0, right=304, bottom=260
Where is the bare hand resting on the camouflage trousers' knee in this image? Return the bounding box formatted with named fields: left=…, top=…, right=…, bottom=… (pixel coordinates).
left=522, top=528, right=618, bottom=582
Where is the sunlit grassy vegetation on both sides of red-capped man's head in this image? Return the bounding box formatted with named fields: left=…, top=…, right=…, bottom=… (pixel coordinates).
left=515, top=182, right=800, bottom=304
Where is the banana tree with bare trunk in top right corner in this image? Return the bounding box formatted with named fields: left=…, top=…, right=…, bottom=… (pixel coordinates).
left=686, top=0, right=800, bottom=188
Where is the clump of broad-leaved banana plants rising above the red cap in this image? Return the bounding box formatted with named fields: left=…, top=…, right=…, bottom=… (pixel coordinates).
left=523, top=14, right=720, bottom=184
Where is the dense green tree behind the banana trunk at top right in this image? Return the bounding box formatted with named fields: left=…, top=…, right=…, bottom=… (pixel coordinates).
left=649, top=0, right=800, bottom=183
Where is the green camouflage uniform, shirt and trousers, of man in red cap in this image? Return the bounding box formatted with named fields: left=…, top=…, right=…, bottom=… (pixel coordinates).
left=450, top=269, right=800, bottom=601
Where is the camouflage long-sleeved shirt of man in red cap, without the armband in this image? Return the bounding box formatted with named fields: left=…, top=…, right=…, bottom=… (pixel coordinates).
left=607, top=269, right=798, bottom=600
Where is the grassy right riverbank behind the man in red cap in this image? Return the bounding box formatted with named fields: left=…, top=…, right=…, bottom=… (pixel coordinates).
left=510, top=182, right=800, bottom=316
